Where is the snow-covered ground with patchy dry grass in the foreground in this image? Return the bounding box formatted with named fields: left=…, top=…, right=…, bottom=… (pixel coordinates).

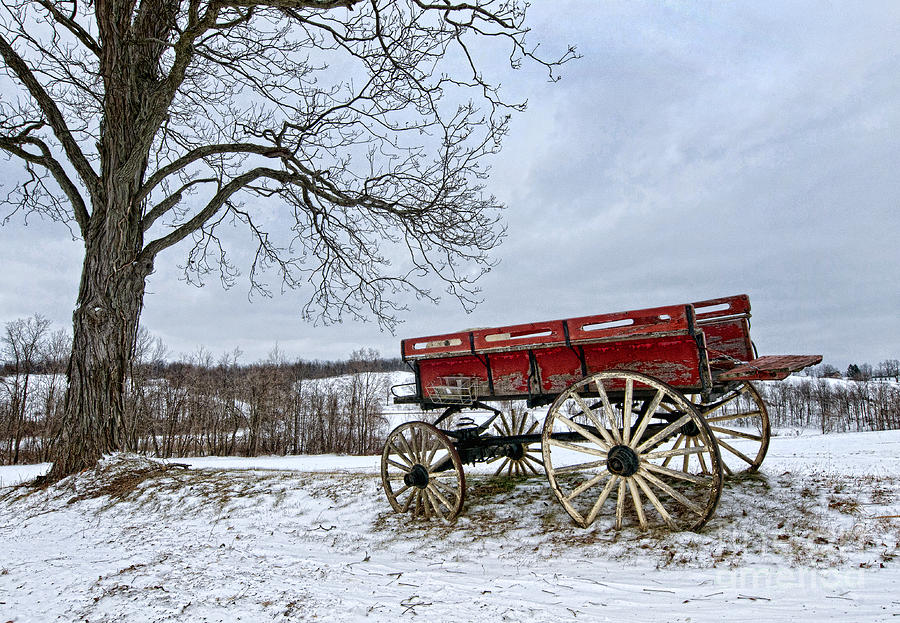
left=0, top=431, right=900, bottom=622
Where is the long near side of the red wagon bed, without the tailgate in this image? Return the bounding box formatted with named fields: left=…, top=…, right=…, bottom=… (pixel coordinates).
left=395, top=305, right=712, bottom=408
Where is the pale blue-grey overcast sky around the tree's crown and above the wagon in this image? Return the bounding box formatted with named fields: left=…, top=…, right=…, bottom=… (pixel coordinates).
left=0, top=0, right=900, bottom=368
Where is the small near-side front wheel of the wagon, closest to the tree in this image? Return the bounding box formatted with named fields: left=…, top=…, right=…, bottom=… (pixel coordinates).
left=381, top=422, right=466, bottom=521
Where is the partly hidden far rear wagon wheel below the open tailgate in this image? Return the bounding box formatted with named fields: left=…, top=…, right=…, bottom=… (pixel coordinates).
left=696, top=382, right=771, bottom=476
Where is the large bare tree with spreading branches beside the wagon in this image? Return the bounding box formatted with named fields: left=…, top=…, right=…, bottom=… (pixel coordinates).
left=0, top=0, right=574, bottom=478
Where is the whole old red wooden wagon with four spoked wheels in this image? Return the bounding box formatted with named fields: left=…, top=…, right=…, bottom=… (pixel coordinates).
left=381, top=295, right=822, bottom=530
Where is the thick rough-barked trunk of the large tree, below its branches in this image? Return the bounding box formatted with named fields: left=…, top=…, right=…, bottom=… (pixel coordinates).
left=49, top=236, right=153, bottom=480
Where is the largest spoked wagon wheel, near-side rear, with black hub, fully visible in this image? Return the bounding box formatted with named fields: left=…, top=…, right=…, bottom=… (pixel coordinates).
left=541, top=371, right=722, bottom=530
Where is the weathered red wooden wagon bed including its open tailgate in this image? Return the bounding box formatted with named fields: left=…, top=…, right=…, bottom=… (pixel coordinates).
left=394, top=295, right=821, bottom=409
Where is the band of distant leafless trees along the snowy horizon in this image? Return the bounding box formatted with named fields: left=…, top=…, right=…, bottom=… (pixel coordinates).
left=0, top=316, right=900, bottom=464
